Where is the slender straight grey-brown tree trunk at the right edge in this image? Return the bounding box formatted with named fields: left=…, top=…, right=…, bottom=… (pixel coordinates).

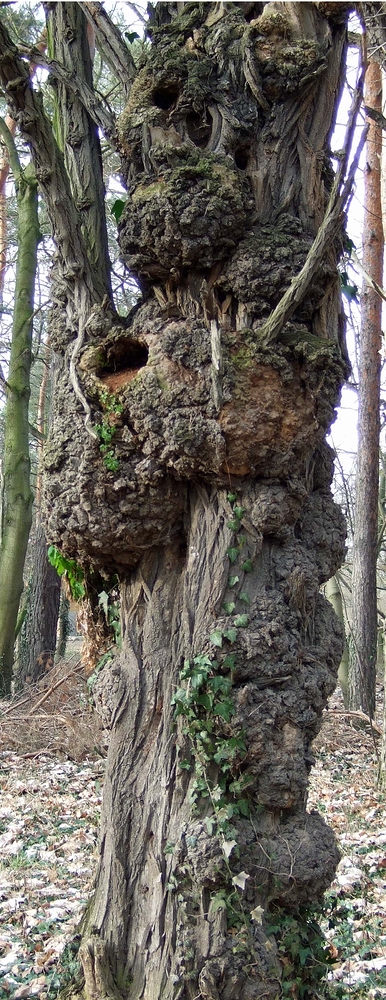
left=349, top=60, right=383, bottom=717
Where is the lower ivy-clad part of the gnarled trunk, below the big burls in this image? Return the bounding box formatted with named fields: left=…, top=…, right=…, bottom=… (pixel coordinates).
left=78, top=476, right=341, bottom=998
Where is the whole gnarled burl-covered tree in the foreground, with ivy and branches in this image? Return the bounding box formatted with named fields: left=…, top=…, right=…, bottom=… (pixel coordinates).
left=0, top=3, right=360, bottom=1000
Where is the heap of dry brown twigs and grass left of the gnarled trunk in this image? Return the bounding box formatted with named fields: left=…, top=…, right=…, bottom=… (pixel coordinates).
left=0, top=653, right=106, bottom=761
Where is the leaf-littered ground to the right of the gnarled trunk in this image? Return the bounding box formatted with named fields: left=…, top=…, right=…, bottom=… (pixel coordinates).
left=309, top=695, right=386, bottom=1000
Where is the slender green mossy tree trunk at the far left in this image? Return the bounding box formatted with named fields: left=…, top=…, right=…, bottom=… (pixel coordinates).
left=0, top=125, right=39, bottom=691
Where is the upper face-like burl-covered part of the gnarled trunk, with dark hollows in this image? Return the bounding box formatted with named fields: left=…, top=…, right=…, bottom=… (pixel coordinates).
left=43, top=3, right=343, bottom=565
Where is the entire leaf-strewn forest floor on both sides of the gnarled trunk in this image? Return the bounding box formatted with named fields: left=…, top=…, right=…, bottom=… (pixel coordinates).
left=0, top=659, right=386, bottom=1000
